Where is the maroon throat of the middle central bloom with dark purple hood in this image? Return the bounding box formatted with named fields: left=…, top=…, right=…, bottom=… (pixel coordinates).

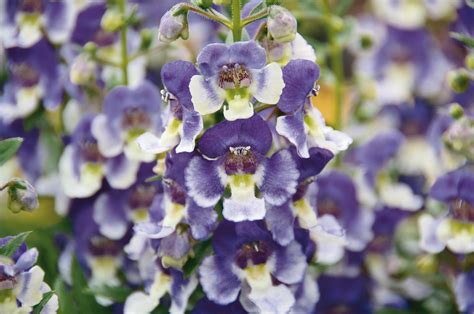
left=224, top=146, right=259, bottom=175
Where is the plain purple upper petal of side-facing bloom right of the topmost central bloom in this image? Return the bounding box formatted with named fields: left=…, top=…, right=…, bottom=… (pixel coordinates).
left=277, top=60, right=319, bottom=113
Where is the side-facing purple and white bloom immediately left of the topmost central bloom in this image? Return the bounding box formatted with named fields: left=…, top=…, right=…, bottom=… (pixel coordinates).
left=137, top=61, right=203, bottom=154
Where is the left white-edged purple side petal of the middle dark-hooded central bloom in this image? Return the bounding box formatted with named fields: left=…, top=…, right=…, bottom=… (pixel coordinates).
left=185, top=157, right=224, bottom=207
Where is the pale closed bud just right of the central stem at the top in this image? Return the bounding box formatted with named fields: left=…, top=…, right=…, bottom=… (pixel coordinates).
left=267, top=5, right=297, bottom=43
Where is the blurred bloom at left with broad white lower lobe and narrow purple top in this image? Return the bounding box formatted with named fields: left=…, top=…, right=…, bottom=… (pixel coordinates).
left=59, top=115, right=139, bottom=198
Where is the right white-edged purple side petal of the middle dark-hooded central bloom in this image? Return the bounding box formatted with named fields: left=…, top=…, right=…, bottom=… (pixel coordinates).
left=260, top=150, right=299, bottom=206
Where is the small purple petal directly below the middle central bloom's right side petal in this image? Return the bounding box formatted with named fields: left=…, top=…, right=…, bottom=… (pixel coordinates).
left=265, top=202, right=295, bottom=245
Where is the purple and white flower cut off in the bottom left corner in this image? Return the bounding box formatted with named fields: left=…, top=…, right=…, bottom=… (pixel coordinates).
left=0, top=237, right=59, bottom=314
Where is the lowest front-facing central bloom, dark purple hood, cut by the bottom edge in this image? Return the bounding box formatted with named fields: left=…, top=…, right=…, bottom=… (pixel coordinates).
left=199, top=221, right=307, bottom=313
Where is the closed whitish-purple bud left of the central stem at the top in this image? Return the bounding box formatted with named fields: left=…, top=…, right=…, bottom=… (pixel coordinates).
left=159, top=4, right=189, bottom=43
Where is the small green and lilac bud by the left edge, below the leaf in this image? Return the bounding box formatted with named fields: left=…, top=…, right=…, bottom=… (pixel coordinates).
left=7, top=179, right=39, bottom=213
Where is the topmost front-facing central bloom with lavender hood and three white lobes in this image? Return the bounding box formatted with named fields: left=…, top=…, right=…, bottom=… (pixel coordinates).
left=189, top=41, right=285, bottom=120
